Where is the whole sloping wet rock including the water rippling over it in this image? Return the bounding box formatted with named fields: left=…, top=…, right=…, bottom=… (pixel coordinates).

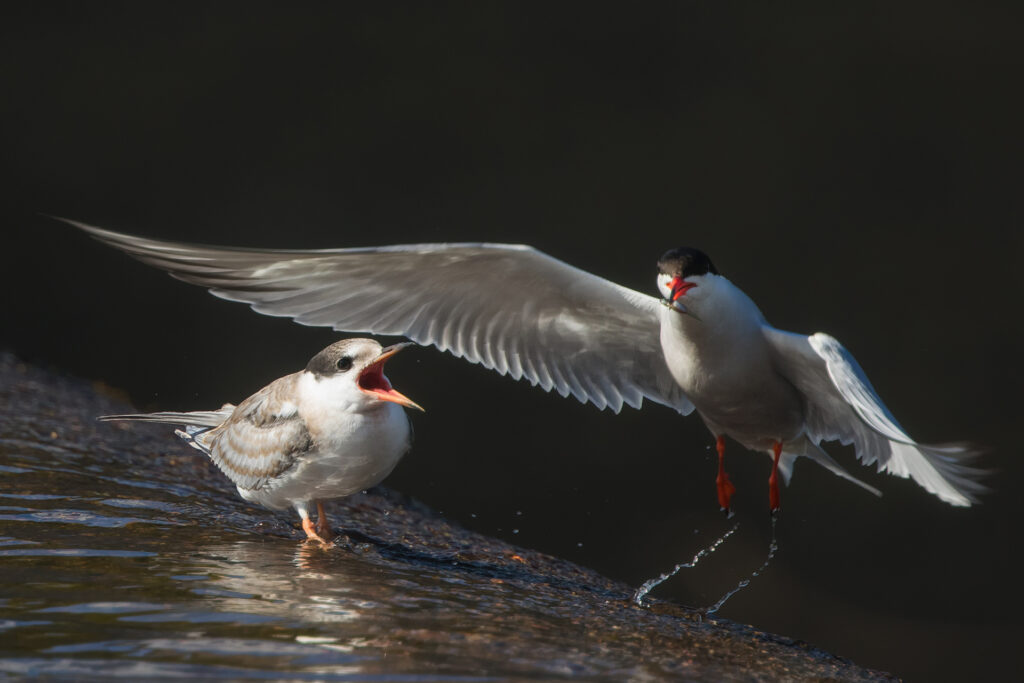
left=0, top=354, right=893, bottom=681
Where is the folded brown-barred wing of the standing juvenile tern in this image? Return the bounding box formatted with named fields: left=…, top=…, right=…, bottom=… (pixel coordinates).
left=201, top=374, right=311, bottom=490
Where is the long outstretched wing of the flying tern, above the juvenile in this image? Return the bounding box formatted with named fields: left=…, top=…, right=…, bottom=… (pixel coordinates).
left=67, top=221, right=693, bottom=415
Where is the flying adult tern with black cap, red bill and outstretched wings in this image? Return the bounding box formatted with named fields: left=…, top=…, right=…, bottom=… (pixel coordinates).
left=67, top=221, right=985, bottom=511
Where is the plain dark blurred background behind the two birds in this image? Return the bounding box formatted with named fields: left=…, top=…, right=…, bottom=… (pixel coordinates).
left=0, top=2, right=1024, bottom=680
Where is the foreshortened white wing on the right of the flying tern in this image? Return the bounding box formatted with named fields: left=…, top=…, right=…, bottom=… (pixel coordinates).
left=765, top=327, right=985, bottom=506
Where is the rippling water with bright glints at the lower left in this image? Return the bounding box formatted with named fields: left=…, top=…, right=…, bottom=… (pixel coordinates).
left=0, top=413, right=630, bottom=680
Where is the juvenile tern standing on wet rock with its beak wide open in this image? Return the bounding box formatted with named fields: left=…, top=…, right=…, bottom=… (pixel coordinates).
left=99, top=339, right=423, bottom=544
